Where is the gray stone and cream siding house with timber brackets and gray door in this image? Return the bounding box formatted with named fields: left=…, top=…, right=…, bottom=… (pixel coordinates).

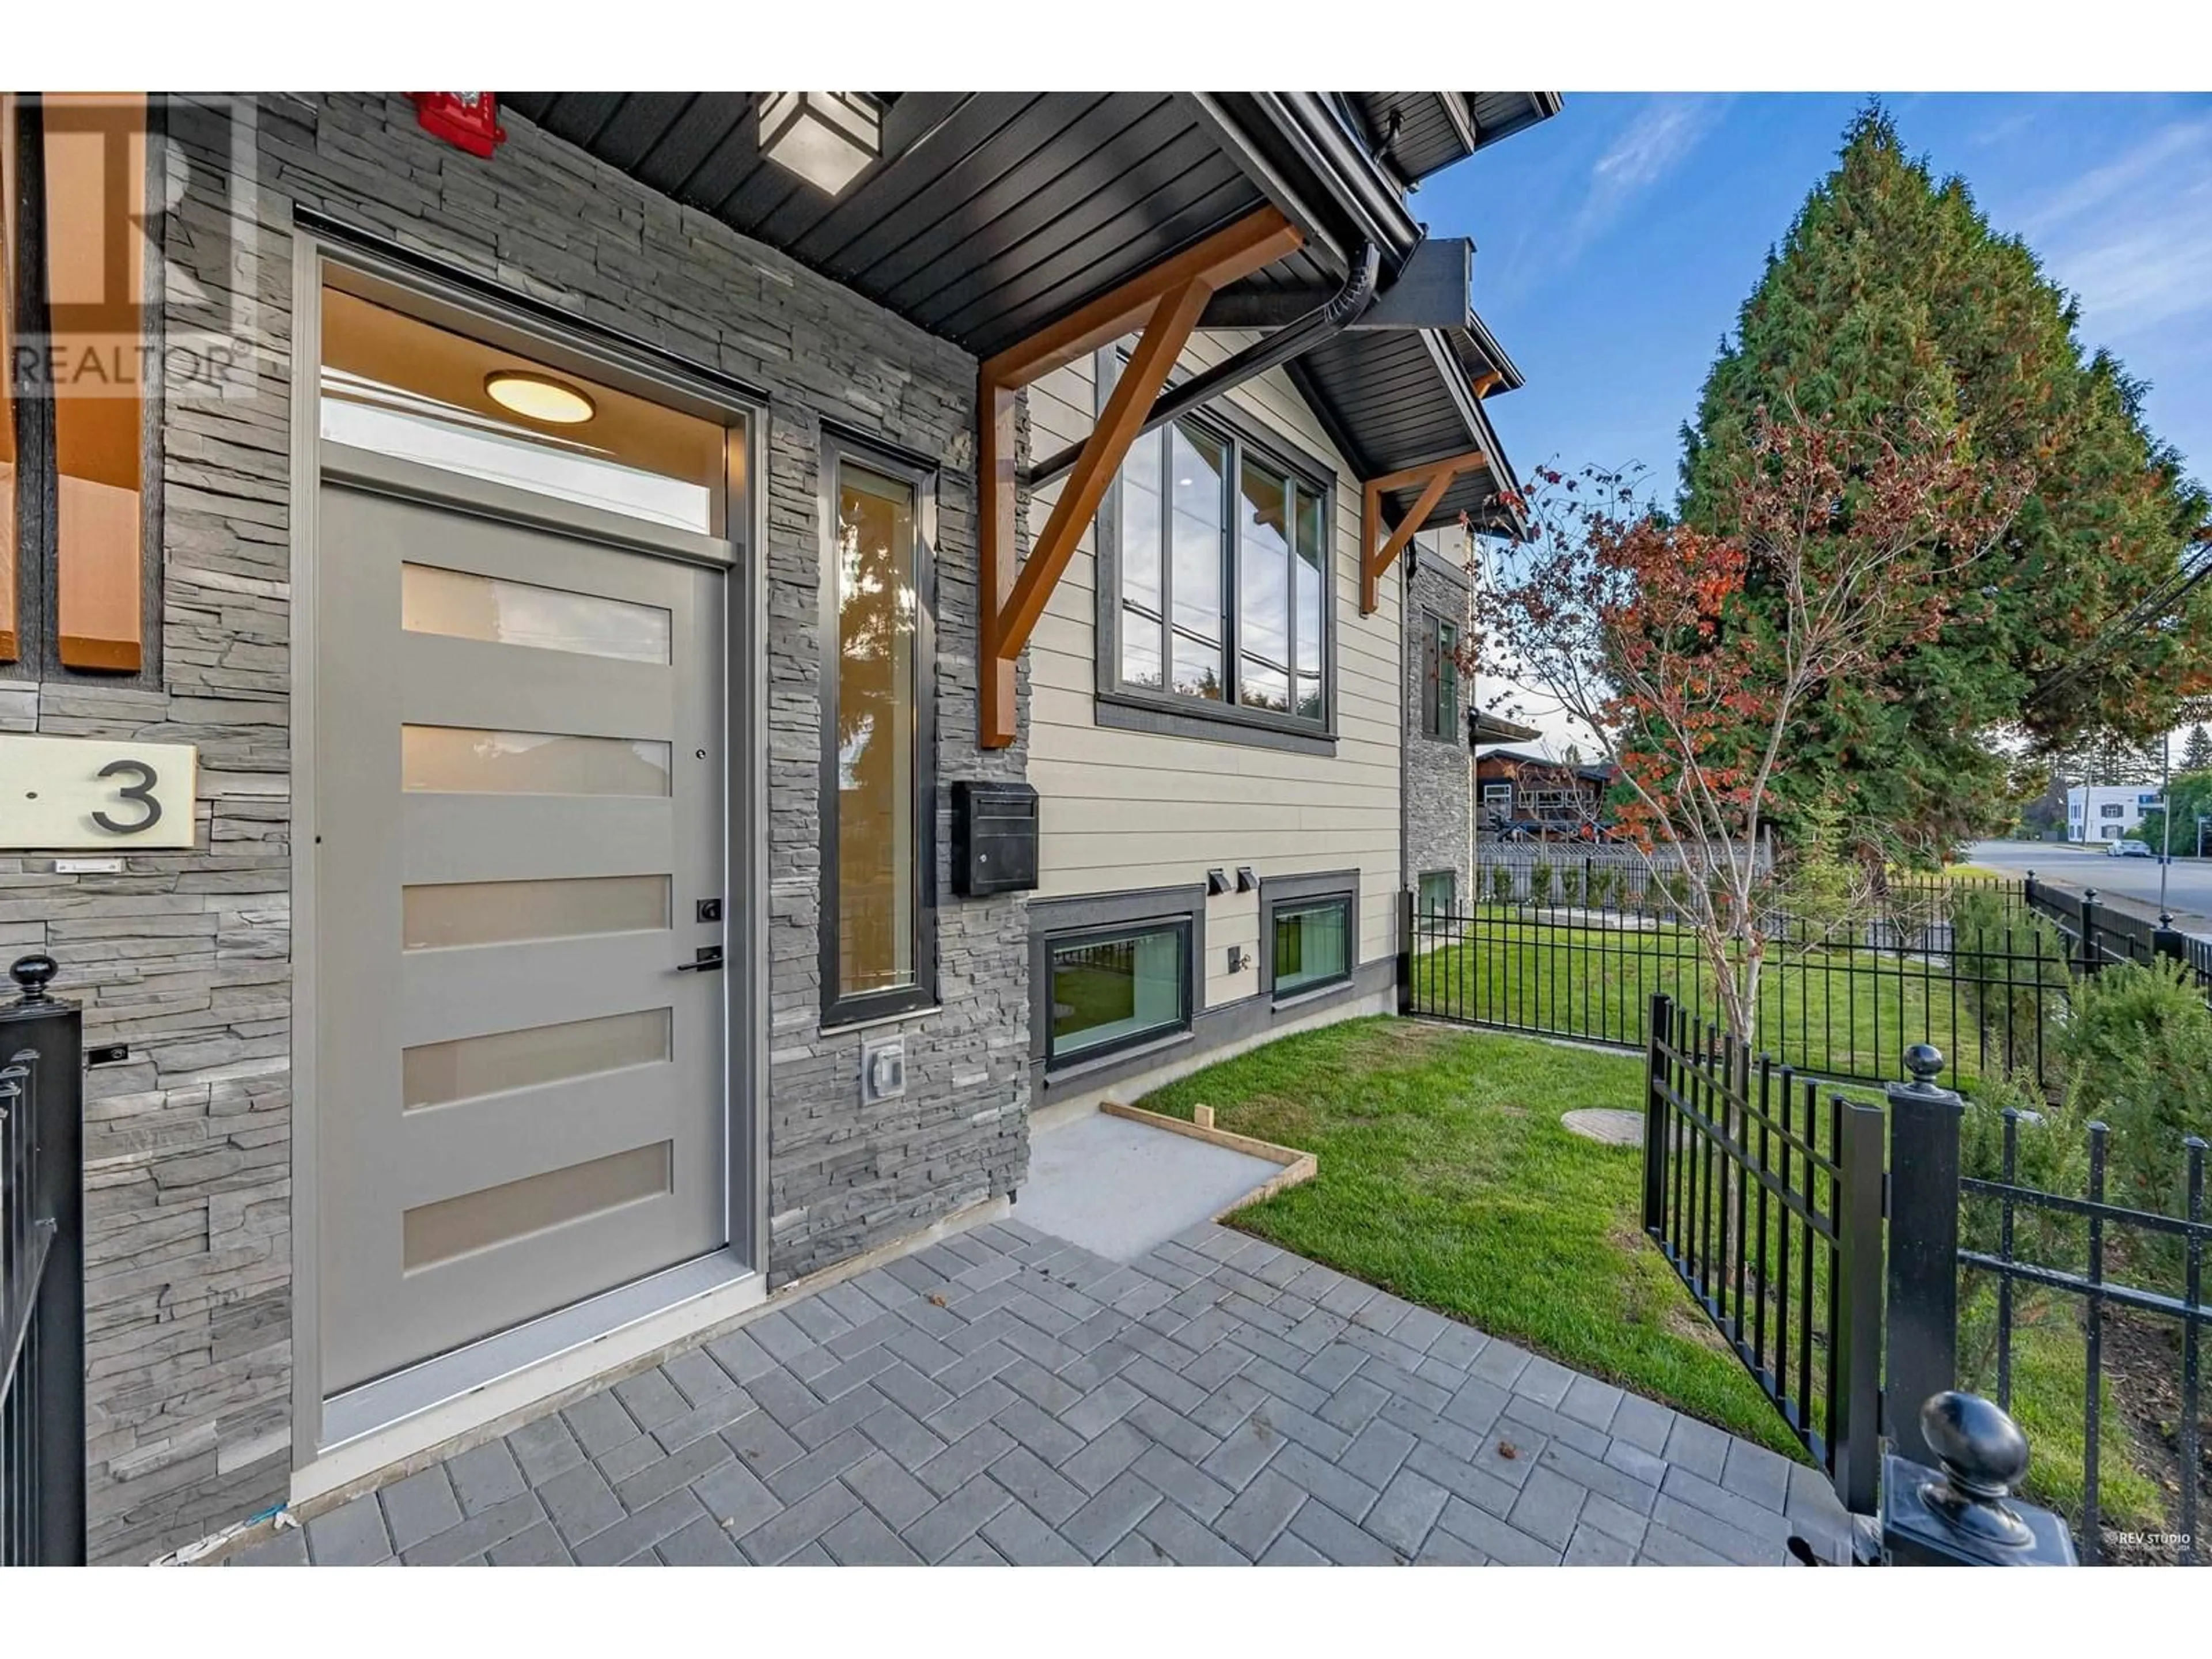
left=0, top=93, right=1557, bottom=1562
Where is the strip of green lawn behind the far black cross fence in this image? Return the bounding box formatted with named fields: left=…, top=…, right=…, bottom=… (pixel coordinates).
left=1414, top=905, right=2026, bottom=1088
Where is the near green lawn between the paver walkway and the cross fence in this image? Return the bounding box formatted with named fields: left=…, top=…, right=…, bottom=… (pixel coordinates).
left=1141, top=1017, right=2150, bottom=1524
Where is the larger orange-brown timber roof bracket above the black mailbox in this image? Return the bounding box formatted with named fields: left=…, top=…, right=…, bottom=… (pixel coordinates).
left=975, top=208, right=1305, bottom=750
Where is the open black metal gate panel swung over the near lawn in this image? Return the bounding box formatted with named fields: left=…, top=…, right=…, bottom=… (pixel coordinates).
left=1643, top=993, right=1883, bottom=1513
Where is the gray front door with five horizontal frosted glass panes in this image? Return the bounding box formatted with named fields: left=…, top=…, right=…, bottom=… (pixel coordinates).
left=314, top=480, right=734, bottom=1393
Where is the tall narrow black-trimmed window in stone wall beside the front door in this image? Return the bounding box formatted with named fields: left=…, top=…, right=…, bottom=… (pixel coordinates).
left=819, top=434, right=935, bottom=1024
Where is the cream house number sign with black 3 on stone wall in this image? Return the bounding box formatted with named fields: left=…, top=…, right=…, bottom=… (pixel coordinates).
left=0, top=737, right=199, bottom=851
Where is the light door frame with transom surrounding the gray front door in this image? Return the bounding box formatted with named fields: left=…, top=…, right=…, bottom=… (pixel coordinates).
left=290, top=226, right=770, bottom=1471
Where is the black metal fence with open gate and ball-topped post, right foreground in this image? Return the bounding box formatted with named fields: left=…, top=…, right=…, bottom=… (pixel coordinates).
left=1641, top=993, right=2212, bottom=1564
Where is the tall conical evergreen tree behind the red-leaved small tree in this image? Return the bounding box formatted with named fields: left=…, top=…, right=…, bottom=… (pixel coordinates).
left=1681, top=106, right=2212, bottom=845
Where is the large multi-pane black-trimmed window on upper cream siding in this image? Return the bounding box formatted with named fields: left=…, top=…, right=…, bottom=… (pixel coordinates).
left=1099, top=352, right=1334, bottom=743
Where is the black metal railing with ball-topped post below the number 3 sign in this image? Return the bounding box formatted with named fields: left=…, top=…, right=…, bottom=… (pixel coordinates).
left=0, top=956, right=84, bottom=1566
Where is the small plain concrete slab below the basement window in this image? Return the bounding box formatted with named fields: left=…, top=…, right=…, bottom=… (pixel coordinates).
left=1016, top=1113, right=1283, bottom=1261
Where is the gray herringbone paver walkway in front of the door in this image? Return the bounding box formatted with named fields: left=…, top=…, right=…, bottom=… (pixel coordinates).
left=232, top=1221, right=1849, bottom=1566
